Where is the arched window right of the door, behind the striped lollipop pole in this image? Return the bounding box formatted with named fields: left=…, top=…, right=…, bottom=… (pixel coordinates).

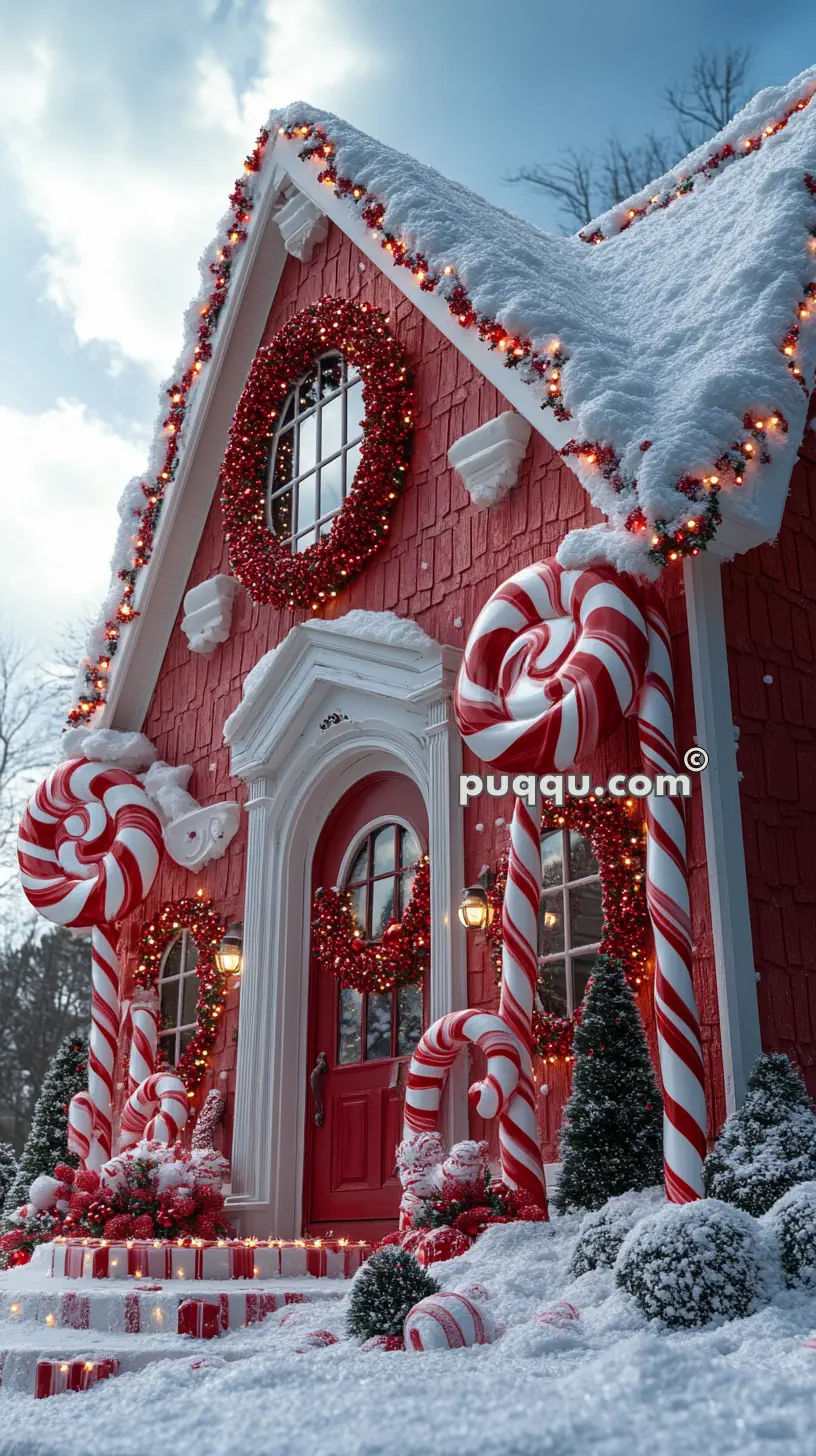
left=538, top=828, right=603, bottom=1016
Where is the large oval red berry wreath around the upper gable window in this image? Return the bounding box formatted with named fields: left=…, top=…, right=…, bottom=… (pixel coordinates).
left=221, top=298, right=414, bottom=610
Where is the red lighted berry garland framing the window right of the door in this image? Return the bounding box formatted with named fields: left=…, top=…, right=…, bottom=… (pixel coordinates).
left=487, top=796, right=651, bottom=1061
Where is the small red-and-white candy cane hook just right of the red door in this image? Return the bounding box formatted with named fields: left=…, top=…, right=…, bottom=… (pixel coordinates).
left=402, top=1010, right=523, bottom=1139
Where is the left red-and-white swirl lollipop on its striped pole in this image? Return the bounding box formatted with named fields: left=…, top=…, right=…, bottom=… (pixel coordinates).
left=17, top=759, right=162, bottom=1168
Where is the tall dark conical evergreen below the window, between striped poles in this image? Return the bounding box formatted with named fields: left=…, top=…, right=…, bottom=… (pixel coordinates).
left=554, top=955, right=663, bottom=1213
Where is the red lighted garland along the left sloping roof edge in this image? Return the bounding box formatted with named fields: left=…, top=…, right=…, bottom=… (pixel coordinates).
left=67, top=128, right=270, bottom=724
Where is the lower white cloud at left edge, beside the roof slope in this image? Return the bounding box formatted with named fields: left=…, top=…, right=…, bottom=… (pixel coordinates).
left=0, top=399, right=147, bottom=642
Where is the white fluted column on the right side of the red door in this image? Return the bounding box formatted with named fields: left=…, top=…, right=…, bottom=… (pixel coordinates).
left=427, top=692, right=469, bottom=1147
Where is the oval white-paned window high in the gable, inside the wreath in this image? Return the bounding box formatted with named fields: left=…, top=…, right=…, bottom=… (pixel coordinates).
left=267, top=352, right=363, bottom=552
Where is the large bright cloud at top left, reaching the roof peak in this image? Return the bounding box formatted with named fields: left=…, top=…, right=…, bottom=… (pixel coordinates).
left=0, top=0, right=377, bottom=379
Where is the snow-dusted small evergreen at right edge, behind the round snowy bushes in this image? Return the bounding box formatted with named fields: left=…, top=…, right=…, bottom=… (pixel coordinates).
left=702, top=1051, right=816, bottom=1217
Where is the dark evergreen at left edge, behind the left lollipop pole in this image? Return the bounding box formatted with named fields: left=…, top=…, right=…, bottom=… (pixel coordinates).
left=3, top=1037, right=87, bottom=1219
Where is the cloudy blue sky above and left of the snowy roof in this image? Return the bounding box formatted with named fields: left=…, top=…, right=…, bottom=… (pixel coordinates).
left=0, top=0, right=816, bottom=663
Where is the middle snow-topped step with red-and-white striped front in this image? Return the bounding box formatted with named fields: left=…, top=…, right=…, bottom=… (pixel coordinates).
left=0, top=1275, right=348, bottom=1348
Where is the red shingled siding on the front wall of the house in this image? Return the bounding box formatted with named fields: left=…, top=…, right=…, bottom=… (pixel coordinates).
left=115, top=226, right=721, bottom=1158
